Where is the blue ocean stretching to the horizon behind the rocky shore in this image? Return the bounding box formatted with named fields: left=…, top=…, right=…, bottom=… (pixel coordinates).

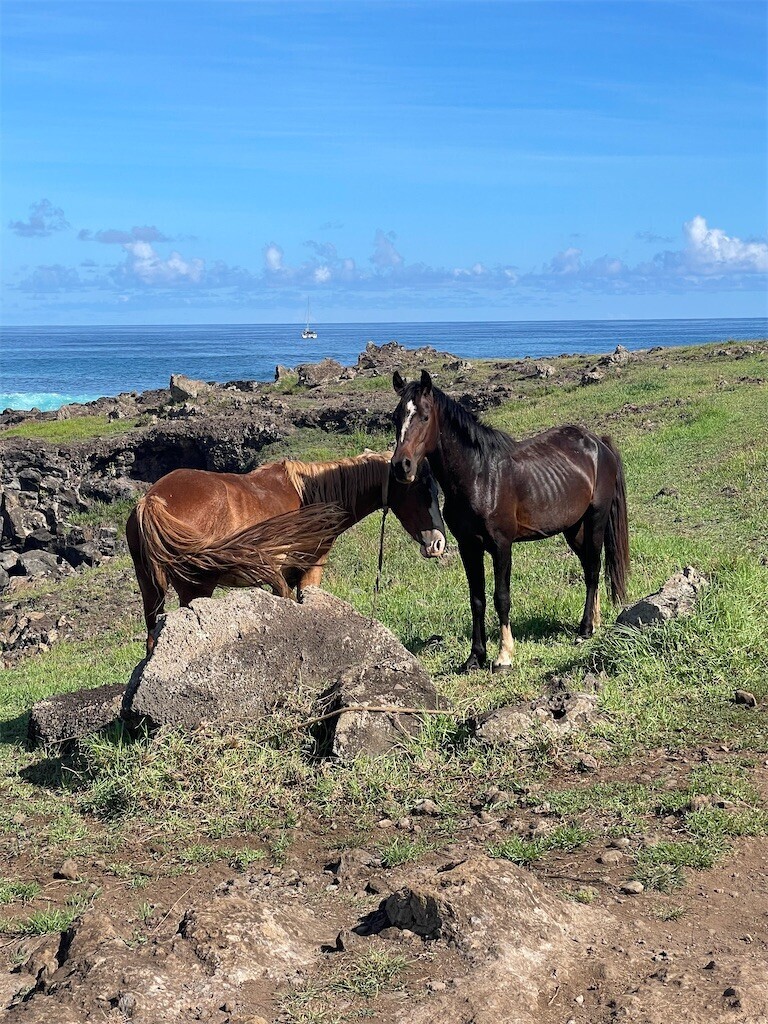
left=0, top=317, right=768, bottom=411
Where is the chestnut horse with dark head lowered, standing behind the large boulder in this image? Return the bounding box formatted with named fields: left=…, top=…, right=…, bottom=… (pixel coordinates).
left=126, top=453, right=445, bottom=651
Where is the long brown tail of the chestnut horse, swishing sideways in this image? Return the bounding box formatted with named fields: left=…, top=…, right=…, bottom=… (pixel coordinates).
left=136, top=495, right=344, bottom=597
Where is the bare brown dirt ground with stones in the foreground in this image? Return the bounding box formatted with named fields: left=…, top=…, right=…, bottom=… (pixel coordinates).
left=0, top=790, right=768, bottom=1024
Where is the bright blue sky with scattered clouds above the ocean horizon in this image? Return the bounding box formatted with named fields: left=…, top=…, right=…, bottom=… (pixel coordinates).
left=0, top=0, right=768, bottom=324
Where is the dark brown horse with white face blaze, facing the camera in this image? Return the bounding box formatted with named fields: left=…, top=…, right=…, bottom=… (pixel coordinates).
left=392, top=371, right=630, bottom=671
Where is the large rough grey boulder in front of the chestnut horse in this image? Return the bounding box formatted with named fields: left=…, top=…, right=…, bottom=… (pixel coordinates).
left=123, top=588, right=437, bottom=757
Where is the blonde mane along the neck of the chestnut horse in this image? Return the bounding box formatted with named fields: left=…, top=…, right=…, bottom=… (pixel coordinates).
left=285, top=452, right=390, bottom=512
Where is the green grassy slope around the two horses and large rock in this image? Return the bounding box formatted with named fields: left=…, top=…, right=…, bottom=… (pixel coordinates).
left=0, top=339, right=768, bottom=930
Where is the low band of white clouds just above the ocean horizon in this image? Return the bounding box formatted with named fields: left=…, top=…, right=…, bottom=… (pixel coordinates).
left=11, top=216, right=768, bottom=307
